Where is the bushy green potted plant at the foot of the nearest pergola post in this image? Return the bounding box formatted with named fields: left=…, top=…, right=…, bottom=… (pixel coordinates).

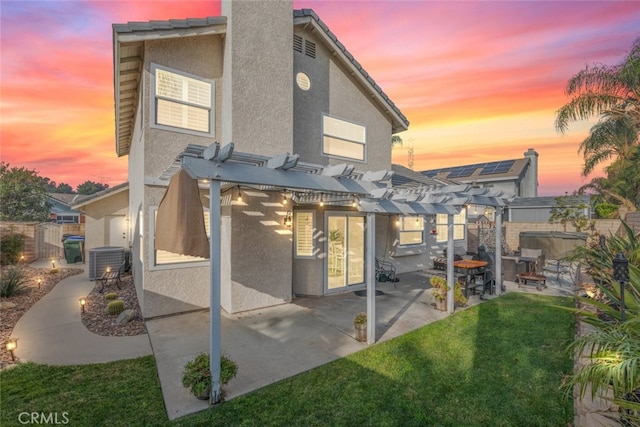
left=182, top=353, right=238, bottom=400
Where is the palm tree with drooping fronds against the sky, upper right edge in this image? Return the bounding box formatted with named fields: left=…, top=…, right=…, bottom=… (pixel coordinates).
left=555, top=38, right=640, bottom=175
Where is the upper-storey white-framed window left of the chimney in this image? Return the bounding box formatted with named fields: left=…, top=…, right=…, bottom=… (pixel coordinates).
left=150, top=64, right=215, bottom=136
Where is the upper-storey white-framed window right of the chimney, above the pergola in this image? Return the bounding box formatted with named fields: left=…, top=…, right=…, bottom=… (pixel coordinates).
left=322, top=115, right=367, bottom=161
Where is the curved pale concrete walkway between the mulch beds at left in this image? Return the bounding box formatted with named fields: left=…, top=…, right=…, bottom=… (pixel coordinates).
left=11, top=262, right=152, bottom=365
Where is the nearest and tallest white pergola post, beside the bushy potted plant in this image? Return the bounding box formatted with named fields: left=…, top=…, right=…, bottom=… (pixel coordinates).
left=209, top=180, right=222, bottom=405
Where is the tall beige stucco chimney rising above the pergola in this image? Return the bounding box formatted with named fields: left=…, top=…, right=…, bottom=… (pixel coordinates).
left=221, top=0, right=293, bottom=156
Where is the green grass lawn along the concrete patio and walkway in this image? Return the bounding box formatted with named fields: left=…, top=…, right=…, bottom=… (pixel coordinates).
left=0, top=294, right=574, bottom=426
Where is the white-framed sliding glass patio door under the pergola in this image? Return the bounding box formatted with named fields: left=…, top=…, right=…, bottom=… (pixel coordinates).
left=325, top=212, right=365, bottom=291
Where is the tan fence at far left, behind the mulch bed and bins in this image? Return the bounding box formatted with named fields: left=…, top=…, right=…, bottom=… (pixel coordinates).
left=0, top=221, right=84, bottom=262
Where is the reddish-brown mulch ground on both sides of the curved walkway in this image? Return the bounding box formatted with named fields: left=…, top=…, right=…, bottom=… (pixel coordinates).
left=0, top=265, right=147, bottom=368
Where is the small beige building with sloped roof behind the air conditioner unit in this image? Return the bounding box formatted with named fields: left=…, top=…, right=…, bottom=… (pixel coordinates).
left=72, top=182, right=130, bottom=251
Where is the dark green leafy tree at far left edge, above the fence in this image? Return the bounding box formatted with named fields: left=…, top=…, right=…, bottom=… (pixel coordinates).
left=0, top=162, right=51, bottom=221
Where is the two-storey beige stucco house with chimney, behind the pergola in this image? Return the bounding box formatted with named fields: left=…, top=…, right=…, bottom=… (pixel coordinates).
left=111, top=1, right=410, bottom=317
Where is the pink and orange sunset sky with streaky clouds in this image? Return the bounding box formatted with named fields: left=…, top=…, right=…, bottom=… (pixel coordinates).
left=0, top=0, right=640, bottom=195
